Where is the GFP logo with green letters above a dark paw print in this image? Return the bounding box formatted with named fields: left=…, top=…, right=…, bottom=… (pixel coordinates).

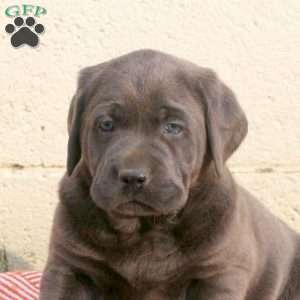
left=5, top=4, right=47, bottom=48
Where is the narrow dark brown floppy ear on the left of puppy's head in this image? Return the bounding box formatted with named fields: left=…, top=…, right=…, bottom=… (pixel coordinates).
left=67, top=89, right=85, bottom=176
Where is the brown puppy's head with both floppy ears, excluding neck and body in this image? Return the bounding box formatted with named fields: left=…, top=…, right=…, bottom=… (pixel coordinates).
left=67, top=50, right=247, bottom=217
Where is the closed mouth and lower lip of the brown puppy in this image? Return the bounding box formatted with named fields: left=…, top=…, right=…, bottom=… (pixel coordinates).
left=114, top=200, right=161, bottom=217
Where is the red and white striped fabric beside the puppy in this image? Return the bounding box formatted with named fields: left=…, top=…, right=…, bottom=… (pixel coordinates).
left=0, top=272, right=42, bottom=300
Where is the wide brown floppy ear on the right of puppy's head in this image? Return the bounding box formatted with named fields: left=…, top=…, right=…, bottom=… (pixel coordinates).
left=200, top=69, right=248, bottom=176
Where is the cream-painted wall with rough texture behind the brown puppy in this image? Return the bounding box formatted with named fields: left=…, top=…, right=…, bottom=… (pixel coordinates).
left=0, top=0, right=300, bottom=269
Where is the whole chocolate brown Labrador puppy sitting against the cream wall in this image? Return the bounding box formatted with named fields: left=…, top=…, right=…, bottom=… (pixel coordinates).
left=40, top=50, right=300, bottom=300
